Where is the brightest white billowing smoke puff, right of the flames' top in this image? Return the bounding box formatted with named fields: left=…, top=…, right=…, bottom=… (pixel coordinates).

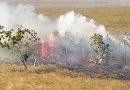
left=58, top=11, right=107, bottom=38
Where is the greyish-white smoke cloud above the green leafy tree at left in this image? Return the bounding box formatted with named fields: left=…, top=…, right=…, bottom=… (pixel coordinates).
left=0, top=3, right=56, bottom=36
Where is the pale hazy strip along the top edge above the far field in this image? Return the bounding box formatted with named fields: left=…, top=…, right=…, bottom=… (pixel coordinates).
left=0, top=0, right=130, bottom=7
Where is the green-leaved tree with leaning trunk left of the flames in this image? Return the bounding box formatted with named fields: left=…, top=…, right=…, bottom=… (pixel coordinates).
left=0, top=26, right=39, bottom=70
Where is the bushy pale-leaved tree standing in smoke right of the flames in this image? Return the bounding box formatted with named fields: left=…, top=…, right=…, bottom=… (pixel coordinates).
left=90, top=34, right=112, bottom=64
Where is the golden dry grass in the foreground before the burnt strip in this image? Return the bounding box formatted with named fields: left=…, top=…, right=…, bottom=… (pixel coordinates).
left=0, top=65, right=130, bottom=90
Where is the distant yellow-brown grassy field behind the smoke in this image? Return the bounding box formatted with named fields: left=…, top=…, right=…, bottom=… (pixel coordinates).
left=37, top=7, right=130, bottom=34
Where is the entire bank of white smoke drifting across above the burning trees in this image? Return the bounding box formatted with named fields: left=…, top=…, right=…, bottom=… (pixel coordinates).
left=0, top=3, right=129, bottom=64
